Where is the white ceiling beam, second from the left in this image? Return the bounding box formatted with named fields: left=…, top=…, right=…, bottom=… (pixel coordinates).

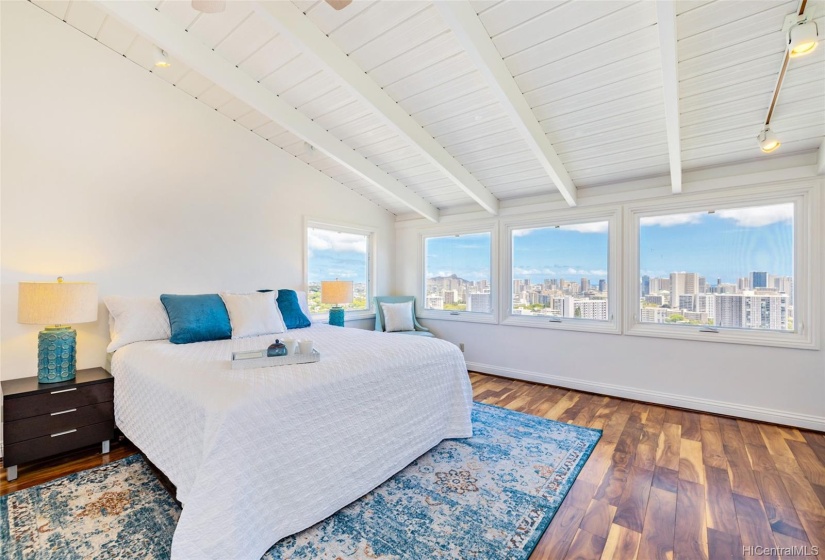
left=251, top=2, right=498, bottom=214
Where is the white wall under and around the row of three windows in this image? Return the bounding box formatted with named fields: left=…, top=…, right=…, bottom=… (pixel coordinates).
left=395, top=174, right=825, bottom=430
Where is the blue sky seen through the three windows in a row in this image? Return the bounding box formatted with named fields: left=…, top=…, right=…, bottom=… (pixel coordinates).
left=426, top=204, right=793, bottom=283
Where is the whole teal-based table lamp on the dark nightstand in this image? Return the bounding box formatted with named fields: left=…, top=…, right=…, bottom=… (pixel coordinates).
left=17, top=278, right=98, bottom=383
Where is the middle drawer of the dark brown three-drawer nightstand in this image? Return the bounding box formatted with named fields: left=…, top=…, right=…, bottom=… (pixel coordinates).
left=3, top=401, right=115, bottom=445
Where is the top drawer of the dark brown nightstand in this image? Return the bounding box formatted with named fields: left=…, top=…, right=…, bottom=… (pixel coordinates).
left=3, top=381, right=114, bottom=422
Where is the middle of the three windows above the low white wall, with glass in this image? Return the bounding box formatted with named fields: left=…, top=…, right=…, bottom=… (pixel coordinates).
left=504, top=209, right=619, bottom=332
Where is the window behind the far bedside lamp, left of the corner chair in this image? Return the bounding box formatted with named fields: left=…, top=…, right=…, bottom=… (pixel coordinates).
left=306, top=223, right=373, bottom=320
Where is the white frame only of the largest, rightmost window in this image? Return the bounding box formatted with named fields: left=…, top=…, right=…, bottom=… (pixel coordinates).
left=624, top=183, right=820, bottom=350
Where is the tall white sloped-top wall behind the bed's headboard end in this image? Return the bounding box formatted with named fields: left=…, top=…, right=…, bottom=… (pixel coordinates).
left=0, top=2, right=395, bottom=379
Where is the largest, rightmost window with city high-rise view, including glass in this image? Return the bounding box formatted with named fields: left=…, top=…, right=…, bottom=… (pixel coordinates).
left=628, top=186, right=816, bottom=347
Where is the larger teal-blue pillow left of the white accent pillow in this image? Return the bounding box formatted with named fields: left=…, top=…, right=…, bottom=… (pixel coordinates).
left=160, top=294, right=232, bottom=344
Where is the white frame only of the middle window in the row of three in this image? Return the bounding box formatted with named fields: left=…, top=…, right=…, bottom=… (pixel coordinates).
left=500, top=206, right=622, bottom=334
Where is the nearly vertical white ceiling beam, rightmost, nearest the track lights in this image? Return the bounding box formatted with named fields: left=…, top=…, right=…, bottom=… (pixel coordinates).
left=656, top=0, right=682, bottom=193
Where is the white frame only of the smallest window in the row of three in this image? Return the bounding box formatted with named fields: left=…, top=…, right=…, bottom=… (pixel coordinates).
left=416, top=222, right=499, bottom=324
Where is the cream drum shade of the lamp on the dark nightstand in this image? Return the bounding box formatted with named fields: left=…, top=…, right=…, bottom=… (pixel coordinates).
left=17, top=279, right=98, bottom=325
